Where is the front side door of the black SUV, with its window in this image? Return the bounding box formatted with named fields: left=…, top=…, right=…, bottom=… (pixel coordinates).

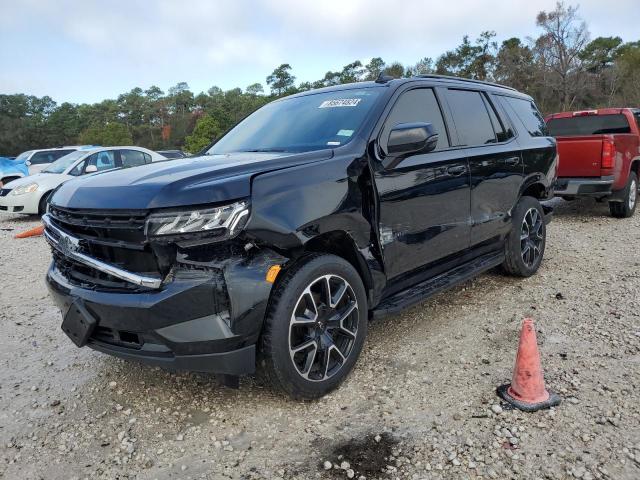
left=374, top=88, right=470, bottom=279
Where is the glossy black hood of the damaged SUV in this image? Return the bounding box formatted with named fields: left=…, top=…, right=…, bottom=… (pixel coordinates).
left=51, top=150, right=333, bottom=210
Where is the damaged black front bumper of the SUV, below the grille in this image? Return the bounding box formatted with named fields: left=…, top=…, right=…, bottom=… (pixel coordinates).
left=46, top=249, right=286, bottom=375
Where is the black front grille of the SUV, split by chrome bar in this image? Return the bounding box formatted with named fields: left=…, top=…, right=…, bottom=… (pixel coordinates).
left=48, top=205, right=161, bottom=291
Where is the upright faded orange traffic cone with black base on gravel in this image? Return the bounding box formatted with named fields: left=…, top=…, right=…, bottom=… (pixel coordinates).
left=498, top=318, right=560, bottom=412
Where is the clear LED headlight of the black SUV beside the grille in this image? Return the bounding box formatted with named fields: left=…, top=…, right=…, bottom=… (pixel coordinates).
left=146, top=201, right=249, bottom=240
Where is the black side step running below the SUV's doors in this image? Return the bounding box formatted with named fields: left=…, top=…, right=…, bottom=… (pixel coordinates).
left=373, top=252, right=504, bottom=319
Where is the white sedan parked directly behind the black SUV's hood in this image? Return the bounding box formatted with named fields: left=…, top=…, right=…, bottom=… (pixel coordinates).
left=0, top=147, right=167, bottom=215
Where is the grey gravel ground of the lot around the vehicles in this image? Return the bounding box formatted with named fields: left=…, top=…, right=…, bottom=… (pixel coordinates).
left=0, top=196, right=640, bottom=480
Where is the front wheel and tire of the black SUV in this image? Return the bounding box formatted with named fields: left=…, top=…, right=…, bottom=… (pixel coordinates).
left=260, top=254, right=368, bottom=400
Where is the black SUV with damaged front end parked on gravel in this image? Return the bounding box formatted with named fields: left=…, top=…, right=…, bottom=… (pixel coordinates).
left=44, top=76, right=557, bottom=398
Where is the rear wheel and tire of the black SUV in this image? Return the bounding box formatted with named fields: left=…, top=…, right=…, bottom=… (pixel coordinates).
left=502, top=197, right=547, bottom=277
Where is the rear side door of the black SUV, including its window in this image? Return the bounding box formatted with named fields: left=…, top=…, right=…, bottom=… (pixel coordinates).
left=447, top=88, right=524, bottom=246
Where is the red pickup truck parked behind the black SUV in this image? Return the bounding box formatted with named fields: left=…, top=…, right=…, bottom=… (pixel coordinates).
left=545, top=108, right=640, bottom=218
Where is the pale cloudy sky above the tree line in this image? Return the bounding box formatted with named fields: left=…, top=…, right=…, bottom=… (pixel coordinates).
left=0, top=0, right=640, bottom=103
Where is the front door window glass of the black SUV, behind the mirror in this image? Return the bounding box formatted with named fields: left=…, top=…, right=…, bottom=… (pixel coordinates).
left=380, top=88, right=449, bottom=150
